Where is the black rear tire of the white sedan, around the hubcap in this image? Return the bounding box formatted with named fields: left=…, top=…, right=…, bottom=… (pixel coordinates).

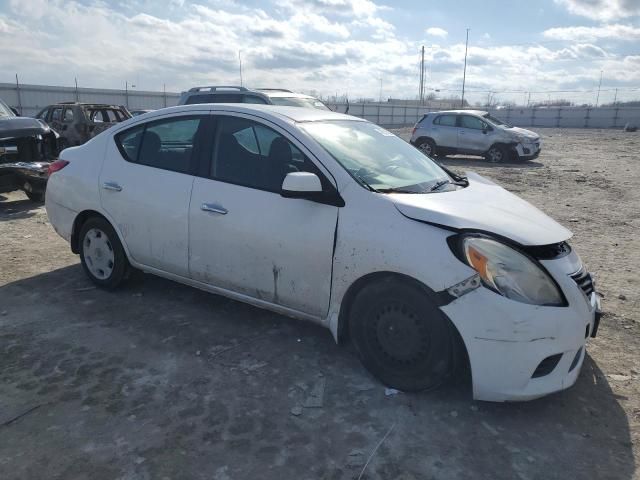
left=78, top=217, right=131, bottom=290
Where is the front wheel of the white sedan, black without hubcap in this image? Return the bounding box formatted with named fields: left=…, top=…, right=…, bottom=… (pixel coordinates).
left=349, top=277, right=456, bottom=392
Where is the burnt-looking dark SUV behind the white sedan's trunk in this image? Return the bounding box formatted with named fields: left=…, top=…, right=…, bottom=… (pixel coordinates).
left=36, top=102, right=131, bottom=150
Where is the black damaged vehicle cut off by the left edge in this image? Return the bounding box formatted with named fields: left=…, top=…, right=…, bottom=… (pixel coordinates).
left=0, top=100, right=59, bottom=202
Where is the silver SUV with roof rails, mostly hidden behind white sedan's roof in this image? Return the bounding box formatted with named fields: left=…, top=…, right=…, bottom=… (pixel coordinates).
left=178, top=85, right=329, bottom=110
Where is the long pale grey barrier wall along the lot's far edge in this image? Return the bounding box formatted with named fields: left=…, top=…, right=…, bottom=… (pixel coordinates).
left=0, top=83, right=640, bottom=128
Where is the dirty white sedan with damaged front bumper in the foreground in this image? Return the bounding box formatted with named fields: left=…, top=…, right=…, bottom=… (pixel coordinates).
left=46, top=104, right=599, bottom=401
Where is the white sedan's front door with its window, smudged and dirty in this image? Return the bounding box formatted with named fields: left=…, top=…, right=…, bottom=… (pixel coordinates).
left=189, top=115, right=338, bottom=317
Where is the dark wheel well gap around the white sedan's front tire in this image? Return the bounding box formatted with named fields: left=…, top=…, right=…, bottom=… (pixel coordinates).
left=338, top=272, right=471, bottom=372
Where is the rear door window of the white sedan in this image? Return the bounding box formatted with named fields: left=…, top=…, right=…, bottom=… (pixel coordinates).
left=115, top=117, right=203, bottom=173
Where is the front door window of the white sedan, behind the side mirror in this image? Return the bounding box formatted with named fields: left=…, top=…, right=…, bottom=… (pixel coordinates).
left=210, top=116, right=319, bottom=192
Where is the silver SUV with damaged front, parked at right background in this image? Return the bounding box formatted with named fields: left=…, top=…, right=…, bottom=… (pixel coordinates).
left=411, top=110, right=541, bottom=162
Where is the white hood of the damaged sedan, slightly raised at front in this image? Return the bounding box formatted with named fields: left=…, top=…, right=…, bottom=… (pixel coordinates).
left=390, top=172, right=573, bottom=245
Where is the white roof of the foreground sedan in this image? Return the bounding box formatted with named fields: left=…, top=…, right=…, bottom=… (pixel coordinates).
left=138, top=103, right=366, bottom=122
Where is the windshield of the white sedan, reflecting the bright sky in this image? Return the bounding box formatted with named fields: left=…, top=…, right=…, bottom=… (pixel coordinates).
left=300, top=120, right=449, bottom=193
